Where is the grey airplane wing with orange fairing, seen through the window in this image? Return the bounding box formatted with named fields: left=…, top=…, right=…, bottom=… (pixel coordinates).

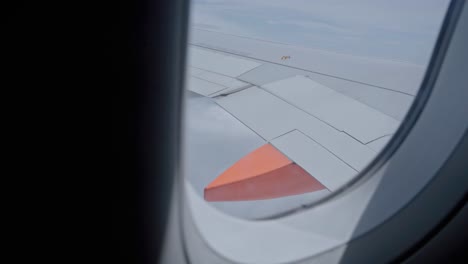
left=186, top=29, right=424, bottom=218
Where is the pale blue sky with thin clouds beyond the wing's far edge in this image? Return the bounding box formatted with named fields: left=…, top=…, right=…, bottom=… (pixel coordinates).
left=190, top=0, right=449, bottom=65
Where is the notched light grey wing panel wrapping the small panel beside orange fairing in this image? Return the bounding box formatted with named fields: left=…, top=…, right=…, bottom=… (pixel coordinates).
left=216, top=87, right=375, bottom=171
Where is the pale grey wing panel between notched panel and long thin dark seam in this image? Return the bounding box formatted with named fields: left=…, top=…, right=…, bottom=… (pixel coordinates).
left=263, top=76, right=399, bottom=144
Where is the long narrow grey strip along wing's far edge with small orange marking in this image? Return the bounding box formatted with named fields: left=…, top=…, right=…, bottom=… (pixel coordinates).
left=189, top=28, right=424, bottom=95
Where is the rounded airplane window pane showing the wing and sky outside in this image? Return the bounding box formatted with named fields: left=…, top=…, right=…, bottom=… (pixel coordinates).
left=184, top=0, right=449, bottom=220
